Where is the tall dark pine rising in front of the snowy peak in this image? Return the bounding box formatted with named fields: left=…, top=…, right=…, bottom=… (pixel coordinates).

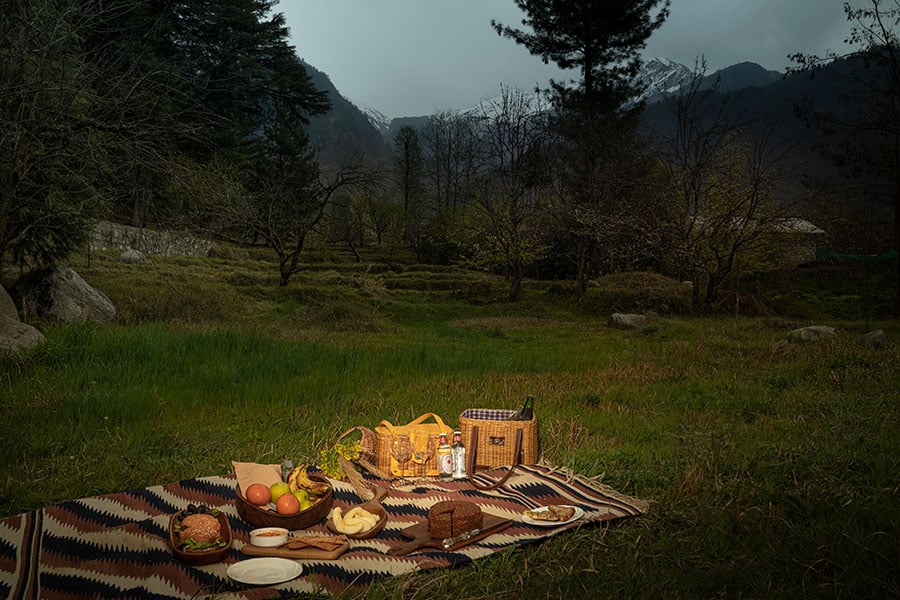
left=491, top=0, right=670, bottom=293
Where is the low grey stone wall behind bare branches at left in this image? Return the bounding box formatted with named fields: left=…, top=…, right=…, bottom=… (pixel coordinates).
left=91, top=221, right=212, bottom=256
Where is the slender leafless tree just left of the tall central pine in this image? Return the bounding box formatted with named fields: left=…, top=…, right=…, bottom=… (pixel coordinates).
left=473, top=88, right=549, bottom=302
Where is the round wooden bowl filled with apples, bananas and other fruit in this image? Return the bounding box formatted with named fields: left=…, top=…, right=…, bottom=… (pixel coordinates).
left=235, top=465, right=334, bottom=531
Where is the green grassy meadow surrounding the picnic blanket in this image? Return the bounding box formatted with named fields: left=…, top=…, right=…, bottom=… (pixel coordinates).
left=0, top=246, right=900, bottom=599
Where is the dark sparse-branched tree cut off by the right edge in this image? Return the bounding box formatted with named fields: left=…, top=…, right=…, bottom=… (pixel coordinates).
left=791, top=0, right=900, bottom=316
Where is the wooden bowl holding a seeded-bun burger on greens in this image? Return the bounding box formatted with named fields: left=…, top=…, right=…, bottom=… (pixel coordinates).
left=169, top=504, right=234, bottom=565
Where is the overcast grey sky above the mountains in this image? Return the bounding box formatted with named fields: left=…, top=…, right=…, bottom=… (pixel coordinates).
left=276, top=0, right=861, bottom=117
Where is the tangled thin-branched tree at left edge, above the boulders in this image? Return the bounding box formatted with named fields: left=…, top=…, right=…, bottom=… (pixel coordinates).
left=0, top=0, right=182, bottom=271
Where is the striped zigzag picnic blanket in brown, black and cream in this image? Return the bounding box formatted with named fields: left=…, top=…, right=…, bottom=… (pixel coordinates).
left=0, top=465, right=647, bottom=600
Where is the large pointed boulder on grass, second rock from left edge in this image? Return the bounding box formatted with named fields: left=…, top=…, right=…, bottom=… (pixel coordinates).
left=16, top=266, right=116, bottom=323
